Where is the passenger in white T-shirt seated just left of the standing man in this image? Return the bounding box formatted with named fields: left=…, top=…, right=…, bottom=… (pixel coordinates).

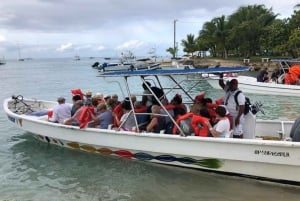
left=207, top=106, right=230, bottom=137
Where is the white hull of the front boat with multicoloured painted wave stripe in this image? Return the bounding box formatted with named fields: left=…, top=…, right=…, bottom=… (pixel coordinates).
left=4, top=99, right=300, bottom=184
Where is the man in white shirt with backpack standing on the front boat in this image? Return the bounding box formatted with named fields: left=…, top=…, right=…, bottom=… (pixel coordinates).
left=219, top=74, right=246, bottom=138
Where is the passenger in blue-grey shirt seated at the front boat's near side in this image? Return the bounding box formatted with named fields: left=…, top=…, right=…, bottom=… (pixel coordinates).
left=89, top=103, right=113, bottom=129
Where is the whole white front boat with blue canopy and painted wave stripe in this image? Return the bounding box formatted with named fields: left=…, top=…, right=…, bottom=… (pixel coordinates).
left=3, top=67, right=300, bottom=184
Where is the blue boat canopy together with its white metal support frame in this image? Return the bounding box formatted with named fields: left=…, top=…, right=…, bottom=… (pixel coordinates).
left=99, top=66, right=249, bottom=136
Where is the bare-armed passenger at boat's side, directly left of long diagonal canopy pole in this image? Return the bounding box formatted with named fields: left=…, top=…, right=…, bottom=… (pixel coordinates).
left=146, top=105, right=166, bottom=133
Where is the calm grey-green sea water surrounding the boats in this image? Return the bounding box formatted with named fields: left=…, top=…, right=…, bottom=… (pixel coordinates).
left=0, top=58, right=300, bottom=201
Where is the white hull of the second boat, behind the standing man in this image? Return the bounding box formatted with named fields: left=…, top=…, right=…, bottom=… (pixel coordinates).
left=207, top=76, right=300, bottom=97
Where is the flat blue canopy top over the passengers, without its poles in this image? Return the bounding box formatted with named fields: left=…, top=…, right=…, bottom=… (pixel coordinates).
left=98, top=66, right=249, bottom=77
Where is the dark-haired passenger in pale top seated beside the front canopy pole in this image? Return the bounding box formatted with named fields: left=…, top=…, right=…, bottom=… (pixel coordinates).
left=114, top=97, right=136, bottom=131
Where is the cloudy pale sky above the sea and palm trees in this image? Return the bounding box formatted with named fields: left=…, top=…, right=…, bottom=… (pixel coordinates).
left=0, top=0, right=299, bottom=59
